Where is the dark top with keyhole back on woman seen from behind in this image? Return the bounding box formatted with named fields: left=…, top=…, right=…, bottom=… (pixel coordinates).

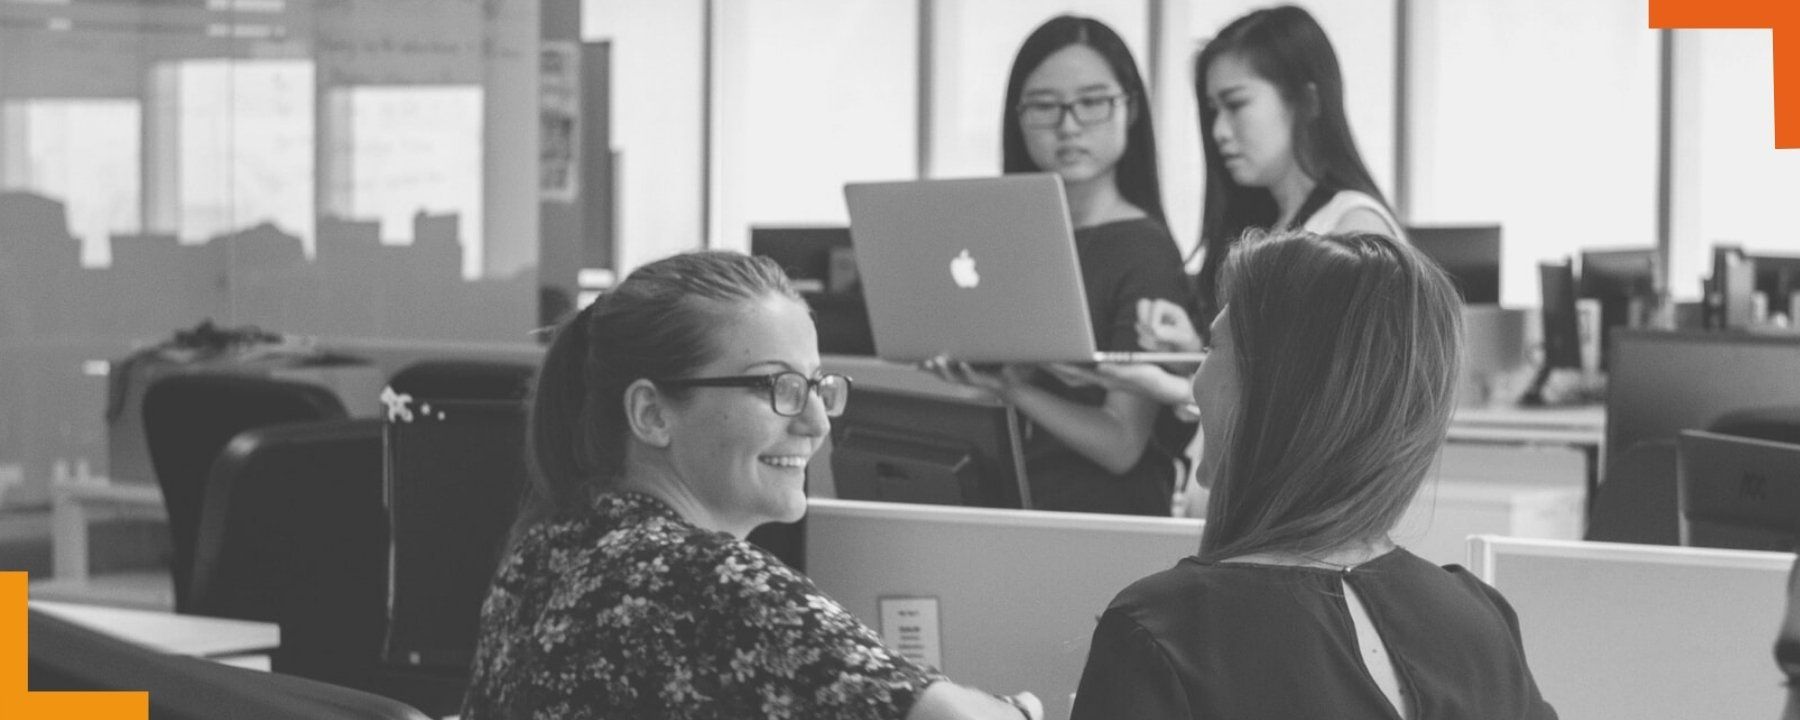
left=1071, top=549, right=1557, bottom=720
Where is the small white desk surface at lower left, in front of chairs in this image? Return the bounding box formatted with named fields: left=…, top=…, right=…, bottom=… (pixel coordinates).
left=31, top=599, right=281, bottom=657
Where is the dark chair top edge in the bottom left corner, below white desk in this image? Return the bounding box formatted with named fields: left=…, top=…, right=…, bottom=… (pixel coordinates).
left=29, top=610, right=427, bottom=720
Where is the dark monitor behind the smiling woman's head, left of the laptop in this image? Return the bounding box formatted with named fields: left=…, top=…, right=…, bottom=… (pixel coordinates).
left=751, top=225, right=875, bottom=356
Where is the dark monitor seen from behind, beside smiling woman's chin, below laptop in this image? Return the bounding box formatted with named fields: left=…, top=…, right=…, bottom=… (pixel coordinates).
left=832, top=387, right=1031, bottom=508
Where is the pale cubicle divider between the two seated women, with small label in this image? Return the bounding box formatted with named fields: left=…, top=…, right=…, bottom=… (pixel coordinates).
left=806, top=499, right=1201, bottom=718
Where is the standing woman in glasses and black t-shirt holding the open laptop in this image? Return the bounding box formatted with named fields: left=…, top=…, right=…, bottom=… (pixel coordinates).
left=927, top=16, right=1192, bottom=515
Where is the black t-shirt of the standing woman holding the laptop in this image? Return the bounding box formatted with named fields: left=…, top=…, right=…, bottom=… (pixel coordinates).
left=1024, top=218, right=1193, bottom=515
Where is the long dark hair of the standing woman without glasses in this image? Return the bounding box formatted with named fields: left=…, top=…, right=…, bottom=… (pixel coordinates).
left=1193, top=5, right=1386, bottom=318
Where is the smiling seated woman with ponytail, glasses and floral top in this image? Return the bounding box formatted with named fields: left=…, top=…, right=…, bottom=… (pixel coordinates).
left=463, top=252, right=1040, bottom=720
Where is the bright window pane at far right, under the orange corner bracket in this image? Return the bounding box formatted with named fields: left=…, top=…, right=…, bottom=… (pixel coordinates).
left=1669, top=31, right=1800, bottom=301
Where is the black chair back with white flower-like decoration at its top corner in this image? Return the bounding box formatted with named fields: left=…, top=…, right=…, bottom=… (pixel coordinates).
left=383, top=362, right=536, bottom=671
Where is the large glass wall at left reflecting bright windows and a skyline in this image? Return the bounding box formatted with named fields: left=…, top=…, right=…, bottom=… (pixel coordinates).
left=0, top=0, right=540, bottom=506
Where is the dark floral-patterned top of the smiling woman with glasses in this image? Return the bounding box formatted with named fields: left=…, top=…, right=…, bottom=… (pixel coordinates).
left=463, top=493, right=943, bottom=720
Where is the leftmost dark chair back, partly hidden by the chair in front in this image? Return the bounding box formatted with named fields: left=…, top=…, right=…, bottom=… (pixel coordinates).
left=144, top=373, right=346, bottom=612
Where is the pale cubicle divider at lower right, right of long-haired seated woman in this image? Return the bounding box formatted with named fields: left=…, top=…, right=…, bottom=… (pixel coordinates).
left=1469, top=536, right=1795, bottom=718
